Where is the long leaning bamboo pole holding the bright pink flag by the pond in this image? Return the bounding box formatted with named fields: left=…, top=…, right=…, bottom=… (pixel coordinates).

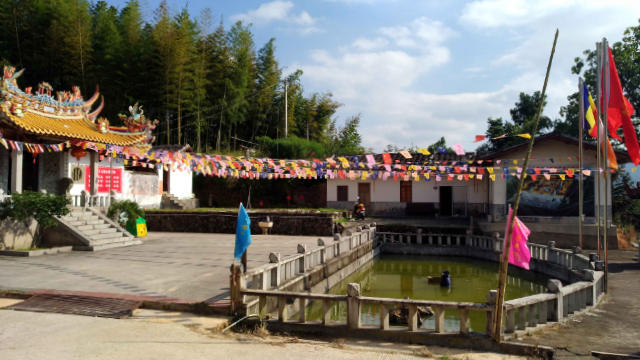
left=493, top=29, right=558, bottom=342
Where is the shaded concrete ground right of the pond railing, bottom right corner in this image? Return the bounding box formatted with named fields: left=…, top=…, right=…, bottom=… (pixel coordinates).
left=522, top=250, right=640, bottom=359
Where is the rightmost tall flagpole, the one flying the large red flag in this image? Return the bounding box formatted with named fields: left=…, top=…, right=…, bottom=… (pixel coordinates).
left=602, top=38, right=611, bottom=292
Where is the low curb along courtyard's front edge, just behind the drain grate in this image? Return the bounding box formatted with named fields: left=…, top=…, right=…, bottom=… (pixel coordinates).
left=0, top=289, right=230, bottom=315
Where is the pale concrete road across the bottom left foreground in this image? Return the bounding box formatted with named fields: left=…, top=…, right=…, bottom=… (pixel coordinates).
left=0, top=302, right=525, bottom=360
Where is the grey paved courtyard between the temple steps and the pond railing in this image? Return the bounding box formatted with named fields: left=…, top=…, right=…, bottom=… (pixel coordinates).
left=0, top=232, right=330, bottom=301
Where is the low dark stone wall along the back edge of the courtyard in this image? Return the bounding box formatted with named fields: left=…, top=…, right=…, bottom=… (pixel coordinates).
left=145, top=211, right=337, bottom=236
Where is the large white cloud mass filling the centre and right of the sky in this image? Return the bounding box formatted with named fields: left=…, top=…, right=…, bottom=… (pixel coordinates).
left=294, top=0, right=640, bottom=151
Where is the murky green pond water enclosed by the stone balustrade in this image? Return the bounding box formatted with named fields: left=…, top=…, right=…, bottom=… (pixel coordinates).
left=307, top=256, right=546, bottom=332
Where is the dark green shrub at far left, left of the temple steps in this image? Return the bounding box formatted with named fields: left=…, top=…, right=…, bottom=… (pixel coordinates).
left=0, top=191, right=71, bottom=229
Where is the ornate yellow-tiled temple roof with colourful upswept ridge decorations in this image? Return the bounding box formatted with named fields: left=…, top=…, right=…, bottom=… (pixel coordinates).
left=0, top=66, right=156, bottom=146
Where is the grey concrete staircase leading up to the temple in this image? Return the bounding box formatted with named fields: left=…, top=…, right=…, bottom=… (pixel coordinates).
left=58, top=208, right=142, bottom=251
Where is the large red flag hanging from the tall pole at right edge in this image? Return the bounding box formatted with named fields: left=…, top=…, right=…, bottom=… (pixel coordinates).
left=605, top=48, right=640, bottom=165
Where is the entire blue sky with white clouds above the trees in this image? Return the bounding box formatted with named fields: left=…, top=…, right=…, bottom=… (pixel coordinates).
left=110, top=0, right=640, bottom=151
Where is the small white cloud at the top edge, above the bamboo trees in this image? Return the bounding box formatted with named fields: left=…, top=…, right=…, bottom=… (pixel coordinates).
left=231, top=0, right=319, bottom=34
